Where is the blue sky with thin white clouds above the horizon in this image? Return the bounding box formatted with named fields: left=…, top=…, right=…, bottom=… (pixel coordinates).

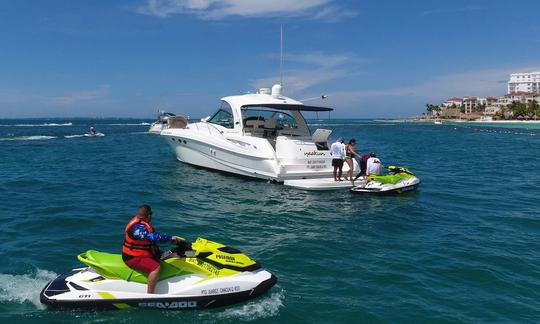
left=0, top=0, right=540, bottom=118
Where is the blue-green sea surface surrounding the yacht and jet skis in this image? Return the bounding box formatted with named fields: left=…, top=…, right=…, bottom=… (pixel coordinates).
left=0, top=119, right=540, bottom=323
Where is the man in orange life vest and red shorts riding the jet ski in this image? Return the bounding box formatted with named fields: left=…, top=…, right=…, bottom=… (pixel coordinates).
left=122, top=205, right=184, bottom=294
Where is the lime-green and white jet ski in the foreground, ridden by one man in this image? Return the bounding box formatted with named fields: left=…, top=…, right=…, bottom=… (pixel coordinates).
left=40, top=238, right=277, bottom=310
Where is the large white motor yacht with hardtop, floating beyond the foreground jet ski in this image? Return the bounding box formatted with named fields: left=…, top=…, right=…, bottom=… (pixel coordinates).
left=160, top=84, right=357, bottom=182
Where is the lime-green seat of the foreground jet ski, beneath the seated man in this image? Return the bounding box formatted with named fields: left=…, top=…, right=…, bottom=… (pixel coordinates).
left=77, top=250, right=190, bottom=284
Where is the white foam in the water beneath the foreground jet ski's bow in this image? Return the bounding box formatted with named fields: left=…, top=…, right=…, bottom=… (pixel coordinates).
left=218, top=291, right=285, bottom=321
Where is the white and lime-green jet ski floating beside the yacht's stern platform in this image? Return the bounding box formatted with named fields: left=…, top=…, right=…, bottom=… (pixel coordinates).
left=351, top=166, right=420, bottom=194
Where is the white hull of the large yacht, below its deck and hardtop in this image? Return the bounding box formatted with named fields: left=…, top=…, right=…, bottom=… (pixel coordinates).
left=161, top=124, right=357, bottom=182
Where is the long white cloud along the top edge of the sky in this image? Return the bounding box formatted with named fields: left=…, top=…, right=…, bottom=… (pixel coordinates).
left=137, top=0, right=356, bottom=21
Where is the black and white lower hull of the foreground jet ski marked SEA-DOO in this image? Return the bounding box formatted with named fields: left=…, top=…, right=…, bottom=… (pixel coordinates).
left=40, top=269, right=277, bottom=310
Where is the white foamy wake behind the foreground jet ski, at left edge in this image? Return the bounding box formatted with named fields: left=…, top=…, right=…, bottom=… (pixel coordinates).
left=0, top=269, right=58, bottom=309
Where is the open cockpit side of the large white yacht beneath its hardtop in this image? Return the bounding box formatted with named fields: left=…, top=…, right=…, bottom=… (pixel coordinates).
left=242, top=106, right=309, bottom=138
